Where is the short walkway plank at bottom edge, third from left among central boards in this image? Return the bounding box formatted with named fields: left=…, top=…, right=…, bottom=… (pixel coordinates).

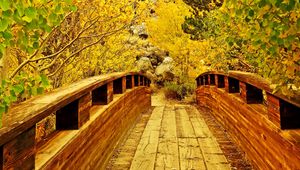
left=178, top=138, right=206, bottom=169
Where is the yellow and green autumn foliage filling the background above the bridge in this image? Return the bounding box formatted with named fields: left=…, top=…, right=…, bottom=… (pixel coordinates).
left=0, top=0, right=300, bottom=125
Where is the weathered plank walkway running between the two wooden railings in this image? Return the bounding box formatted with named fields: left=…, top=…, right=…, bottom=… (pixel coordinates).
left=107, top=93, right=244, bottom=170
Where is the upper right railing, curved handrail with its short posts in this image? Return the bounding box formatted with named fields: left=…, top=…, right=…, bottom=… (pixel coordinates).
left=196, top=71, right=300, bottom=129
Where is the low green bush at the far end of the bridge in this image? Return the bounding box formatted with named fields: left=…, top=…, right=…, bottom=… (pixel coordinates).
left=164, top=81, right=195, bottom=100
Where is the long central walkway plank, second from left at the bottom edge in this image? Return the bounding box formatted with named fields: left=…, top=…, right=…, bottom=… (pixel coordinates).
left=155, top=107, right=179, bottom=169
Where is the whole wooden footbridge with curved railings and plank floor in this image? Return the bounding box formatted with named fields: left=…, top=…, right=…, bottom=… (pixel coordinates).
left=0, top=72, right=300, bottom=169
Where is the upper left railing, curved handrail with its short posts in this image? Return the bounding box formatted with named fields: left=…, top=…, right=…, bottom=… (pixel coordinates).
left=0, top=72, right=151, bottom=169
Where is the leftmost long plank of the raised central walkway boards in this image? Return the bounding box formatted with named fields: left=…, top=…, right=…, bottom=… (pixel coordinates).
left=130, top=106, right=164, bottom=170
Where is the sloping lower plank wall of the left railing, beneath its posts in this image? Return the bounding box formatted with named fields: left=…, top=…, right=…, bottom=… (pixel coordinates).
left=36, top=87, right=151, bottom=169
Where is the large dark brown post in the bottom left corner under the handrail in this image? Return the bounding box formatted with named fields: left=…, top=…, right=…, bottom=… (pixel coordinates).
left=0, top=126, right=36, bottom=170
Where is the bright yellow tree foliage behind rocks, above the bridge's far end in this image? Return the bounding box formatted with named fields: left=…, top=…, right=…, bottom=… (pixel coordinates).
left=146, top=0, right=208, bottom=77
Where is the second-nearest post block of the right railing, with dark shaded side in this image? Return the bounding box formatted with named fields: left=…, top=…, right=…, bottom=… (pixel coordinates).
left=240, top=82, right=263, bottom=104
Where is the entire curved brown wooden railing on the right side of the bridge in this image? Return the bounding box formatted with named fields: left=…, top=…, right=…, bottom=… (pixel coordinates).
left=196, top=71, right=300, bottom=169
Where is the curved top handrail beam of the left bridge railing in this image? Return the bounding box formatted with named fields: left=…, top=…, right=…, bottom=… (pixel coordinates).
left=0, top=72, right=150, bottom=145
